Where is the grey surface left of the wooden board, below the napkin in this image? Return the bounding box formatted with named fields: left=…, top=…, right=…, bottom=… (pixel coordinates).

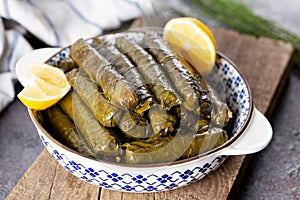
left=0, top=83, right=43, bottom=199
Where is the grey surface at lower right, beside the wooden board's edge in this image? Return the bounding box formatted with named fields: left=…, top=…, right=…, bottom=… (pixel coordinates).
left=237, top=67, right=300, bottom=200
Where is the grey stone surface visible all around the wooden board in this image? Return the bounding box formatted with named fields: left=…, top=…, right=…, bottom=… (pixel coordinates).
left=0, top=0, right=300, bottom=200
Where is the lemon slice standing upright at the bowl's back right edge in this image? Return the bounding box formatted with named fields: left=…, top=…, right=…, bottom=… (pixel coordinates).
left=163, top=17, right=217, bottom=73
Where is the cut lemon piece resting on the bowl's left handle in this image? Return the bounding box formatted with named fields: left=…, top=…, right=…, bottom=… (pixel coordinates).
left=18, top=63, right=71, bottom=110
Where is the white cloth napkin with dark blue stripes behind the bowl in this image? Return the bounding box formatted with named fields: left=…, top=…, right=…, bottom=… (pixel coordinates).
left=0, top=0, right=140, bottom=111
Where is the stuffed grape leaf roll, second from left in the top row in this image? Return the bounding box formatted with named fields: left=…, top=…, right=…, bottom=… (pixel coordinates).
left=91, top=38, right=155, bottom=115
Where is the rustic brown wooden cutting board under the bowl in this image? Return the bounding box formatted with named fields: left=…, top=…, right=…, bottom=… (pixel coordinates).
left=7, top=25, right=293, bottom=200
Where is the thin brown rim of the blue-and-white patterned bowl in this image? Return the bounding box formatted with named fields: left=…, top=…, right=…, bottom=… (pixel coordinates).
left=28, top=43, right=254, bottom=168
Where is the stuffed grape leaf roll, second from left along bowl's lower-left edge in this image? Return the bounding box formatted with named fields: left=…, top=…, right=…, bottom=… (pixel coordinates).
left=72, top=92, right=121, bottom=159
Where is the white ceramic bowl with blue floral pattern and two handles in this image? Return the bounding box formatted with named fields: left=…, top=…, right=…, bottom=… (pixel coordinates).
left=16, top=32, right=272, bottom=192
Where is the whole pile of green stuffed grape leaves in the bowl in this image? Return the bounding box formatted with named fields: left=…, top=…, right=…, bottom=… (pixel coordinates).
left=38, top=33, right=233, bottom=164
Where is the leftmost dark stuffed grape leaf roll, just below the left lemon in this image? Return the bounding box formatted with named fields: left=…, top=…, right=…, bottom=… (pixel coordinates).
left=43, top=106, right=91, bottom=156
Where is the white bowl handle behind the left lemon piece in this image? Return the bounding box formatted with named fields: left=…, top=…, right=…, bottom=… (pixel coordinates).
left=16, top=48, right=61, bottom=87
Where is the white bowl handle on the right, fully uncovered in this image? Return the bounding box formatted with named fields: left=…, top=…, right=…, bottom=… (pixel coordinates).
left=220, top=108, right=273, bottom=155
